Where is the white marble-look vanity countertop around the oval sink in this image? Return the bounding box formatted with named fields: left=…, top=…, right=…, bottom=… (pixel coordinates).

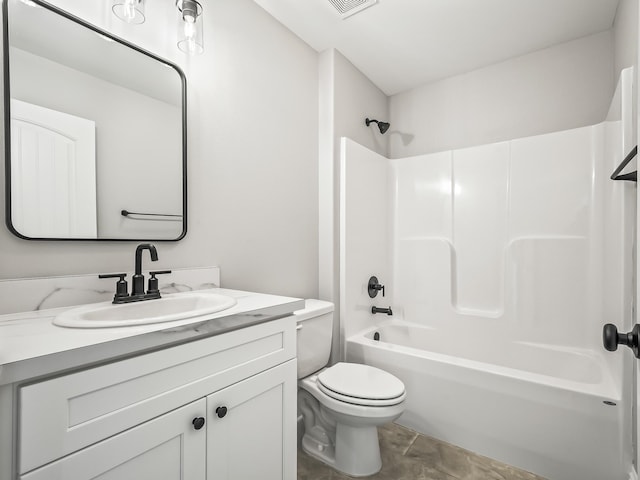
left=0, top=288, right=304, bottom=385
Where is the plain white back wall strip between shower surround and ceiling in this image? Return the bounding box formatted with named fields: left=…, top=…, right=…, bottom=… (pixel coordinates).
left=389, top=31, right=615, bottom=158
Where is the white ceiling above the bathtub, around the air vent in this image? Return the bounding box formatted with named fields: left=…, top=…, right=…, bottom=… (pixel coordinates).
left=254, top=0, right=619, bottom=95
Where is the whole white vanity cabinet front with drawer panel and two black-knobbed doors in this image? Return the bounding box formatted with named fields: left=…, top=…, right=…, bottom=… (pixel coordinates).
left=12, top=317, right=296, bottom=480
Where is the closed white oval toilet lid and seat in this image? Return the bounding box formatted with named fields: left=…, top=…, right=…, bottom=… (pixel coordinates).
left=317, top=363, right=405, bottom=406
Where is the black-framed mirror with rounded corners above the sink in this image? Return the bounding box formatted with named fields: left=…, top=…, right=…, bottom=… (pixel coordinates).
left=3, top=0, right=186, bottom=240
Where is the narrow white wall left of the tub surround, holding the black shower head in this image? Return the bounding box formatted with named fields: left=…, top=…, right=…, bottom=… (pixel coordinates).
left=318, top=49, right=389, bottom=359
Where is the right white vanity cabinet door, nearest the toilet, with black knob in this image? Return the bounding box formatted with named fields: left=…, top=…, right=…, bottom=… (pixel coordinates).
left=207, top=359, right=296, bottom=480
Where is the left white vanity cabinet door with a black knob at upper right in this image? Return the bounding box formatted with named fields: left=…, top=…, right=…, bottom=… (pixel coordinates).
left=20, top=398, right=206, bottom=480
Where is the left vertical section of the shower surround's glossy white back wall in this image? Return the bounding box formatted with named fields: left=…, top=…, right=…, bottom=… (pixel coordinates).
left=390, top=151, right=454, bottom=330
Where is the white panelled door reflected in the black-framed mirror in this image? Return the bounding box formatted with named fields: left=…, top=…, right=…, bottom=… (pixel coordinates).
left=11, top=99, right=97, bottom=238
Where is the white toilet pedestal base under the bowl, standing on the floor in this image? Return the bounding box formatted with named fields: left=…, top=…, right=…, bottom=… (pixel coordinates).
left=302, top=423, right=382, bottom=477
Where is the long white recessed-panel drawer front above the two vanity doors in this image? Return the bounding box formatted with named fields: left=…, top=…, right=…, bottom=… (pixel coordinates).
left=19, top=317, right=295, bottom=473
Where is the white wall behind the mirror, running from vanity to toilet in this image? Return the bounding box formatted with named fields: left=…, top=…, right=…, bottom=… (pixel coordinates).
left=0, top=0, right=318, bottom=297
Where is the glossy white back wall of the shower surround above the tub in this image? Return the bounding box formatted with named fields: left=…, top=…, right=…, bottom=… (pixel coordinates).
left=391, top=125, right=603, bottom=348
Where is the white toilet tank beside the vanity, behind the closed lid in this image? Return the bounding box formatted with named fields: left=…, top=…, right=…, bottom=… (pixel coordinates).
left=293, top=299, right=333, bottom=378
